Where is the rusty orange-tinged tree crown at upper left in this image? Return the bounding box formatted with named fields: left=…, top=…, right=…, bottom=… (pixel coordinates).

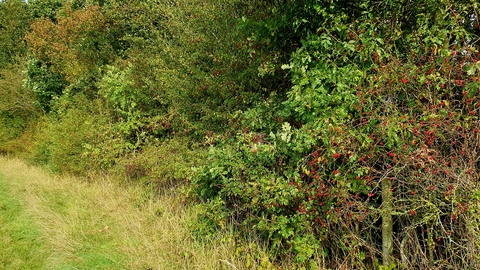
left=25, top=5, right=113, bottom=82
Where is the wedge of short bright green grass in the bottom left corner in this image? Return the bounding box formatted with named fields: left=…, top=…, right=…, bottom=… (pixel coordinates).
left=0, top=175, right=49, bottom=269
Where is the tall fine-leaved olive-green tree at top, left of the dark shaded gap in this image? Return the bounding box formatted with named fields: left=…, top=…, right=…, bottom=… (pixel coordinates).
left=101, top=0, right=280, bottom=140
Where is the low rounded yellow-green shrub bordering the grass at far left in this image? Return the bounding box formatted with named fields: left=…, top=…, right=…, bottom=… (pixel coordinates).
left=36, top=94, right=112, bottom=175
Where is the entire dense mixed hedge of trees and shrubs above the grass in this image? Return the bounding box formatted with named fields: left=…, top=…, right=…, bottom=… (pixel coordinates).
left=0, top=0, right=480, bottom=269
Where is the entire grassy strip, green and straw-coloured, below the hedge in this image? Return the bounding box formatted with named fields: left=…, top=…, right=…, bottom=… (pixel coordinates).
left=0, top=157, right=241, bottom=269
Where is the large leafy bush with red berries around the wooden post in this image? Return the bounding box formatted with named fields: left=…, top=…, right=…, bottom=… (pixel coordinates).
left=195, top=1, right=480, bottom=269
